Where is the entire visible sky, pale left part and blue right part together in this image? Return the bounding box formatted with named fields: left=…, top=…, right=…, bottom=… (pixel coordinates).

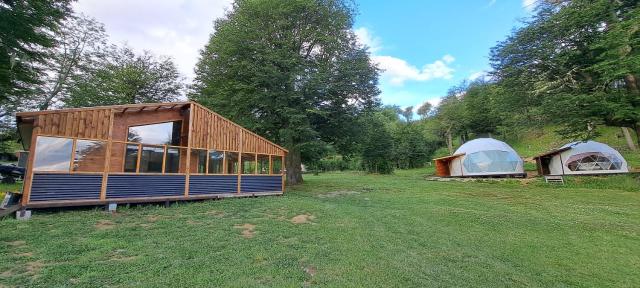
left=73, top=0, right=536, bottom=109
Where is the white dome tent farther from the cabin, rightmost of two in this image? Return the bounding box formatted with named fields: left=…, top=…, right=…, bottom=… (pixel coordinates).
left=541, top=141, right=629, bottom=175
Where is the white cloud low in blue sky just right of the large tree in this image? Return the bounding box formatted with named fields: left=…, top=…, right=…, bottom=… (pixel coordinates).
left=372, top=54, right=455, bottom=86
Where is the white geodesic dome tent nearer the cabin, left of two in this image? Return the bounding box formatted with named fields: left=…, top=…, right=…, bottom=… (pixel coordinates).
left=449, top=138, right=524, bottom=176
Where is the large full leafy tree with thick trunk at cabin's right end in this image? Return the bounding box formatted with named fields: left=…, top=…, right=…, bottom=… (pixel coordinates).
left=189, top=0, right=379, bottom=184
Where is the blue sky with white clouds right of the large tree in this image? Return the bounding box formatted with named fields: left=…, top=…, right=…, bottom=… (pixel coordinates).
left=354, top=0, right=533, bottom=108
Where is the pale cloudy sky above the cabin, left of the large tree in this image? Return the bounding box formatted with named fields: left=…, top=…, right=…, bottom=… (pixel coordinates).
left=73, top=0, right=232, bottom=78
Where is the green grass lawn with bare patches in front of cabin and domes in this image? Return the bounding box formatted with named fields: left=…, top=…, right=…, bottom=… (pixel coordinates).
left=0, top=170, right=640, bottom=287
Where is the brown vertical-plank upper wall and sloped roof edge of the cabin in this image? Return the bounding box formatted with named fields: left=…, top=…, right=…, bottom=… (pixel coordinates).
left=16, top=101, right=288, bottom=155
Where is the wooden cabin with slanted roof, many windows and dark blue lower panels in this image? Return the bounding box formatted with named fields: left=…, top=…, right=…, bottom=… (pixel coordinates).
left=16, top=102, right=287, bottom=208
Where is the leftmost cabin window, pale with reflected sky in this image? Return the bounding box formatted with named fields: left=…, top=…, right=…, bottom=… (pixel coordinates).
left=33, top=136, right=73, bottom=171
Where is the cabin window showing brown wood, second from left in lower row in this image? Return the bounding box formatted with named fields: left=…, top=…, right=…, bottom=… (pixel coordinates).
left=73, top=140, right=107, bottom=172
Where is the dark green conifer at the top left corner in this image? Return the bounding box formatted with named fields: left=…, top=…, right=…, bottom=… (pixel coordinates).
left=0, top=0, right=71, bottom=118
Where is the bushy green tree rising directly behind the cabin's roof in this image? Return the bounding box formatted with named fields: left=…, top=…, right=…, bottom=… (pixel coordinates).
left=64, top=47, right=183, bottom=107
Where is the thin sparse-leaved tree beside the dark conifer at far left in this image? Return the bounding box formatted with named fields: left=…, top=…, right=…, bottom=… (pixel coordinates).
left=35, top=15, right=107, bottom=110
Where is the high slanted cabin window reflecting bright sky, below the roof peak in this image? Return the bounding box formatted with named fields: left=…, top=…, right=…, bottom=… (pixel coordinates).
left=127, top=121, right=182, bottom=146
